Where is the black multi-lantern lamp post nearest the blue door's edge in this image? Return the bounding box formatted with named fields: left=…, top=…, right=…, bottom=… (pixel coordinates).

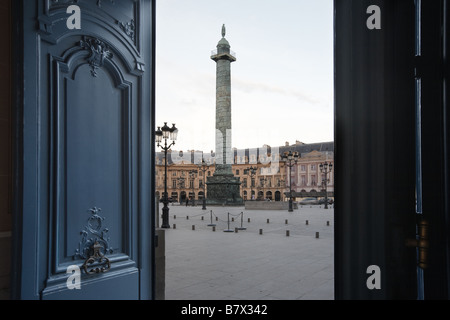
left=155, top=122, right=178, bottom=228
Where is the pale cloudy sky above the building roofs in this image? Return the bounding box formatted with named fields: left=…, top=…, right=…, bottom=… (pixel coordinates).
left=155, top=0, right=334, bottom=152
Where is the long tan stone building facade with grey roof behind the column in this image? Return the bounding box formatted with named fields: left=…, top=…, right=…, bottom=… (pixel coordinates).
left=155, top=141, right=334, bottom=204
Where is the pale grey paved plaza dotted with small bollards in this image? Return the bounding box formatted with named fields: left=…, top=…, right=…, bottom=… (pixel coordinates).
left=165, top=204, right=334, bottom=300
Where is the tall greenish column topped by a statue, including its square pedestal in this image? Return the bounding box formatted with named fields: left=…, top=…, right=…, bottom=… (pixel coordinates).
left=207, top=25, right=243, bottom=205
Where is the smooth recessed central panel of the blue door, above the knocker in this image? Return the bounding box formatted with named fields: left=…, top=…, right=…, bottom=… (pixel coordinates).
left=65, top=65, right=128, bottom=262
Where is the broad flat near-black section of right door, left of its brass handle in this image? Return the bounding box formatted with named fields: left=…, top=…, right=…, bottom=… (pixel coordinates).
left=334, top=0, right=416, bottom=299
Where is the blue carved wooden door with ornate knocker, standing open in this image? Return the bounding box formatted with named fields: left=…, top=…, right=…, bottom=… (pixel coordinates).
left=13, top=0, right=154, bottom=299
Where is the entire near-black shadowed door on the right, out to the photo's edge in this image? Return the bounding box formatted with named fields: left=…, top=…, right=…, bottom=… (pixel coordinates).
left=335, top=0, right=450, bottom=299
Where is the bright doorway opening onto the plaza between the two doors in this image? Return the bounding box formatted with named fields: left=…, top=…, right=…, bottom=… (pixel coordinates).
left=155, top=0, right=334, bottom=300
